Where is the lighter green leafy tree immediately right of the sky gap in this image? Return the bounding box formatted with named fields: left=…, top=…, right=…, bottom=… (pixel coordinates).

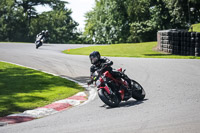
left=84, top=0, right=129, bottom=43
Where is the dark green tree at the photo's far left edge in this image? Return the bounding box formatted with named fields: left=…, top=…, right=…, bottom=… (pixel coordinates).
left=0, top=0, right=26, bottom=41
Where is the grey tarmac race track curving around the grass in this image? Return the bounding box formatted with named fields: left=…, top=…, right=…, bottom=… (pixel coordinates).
left=0, top=43, right=200, bottom=133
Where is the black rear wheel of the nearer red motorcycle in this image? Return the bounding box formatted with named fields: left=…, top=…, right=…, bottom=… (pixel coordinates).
left=131, top=80, right=146, bottom=100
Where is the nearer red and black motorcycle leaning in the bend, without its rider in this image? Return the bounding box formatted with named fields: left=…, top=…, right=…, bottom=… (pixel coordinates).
left=89, top=67, right=146, bottom=107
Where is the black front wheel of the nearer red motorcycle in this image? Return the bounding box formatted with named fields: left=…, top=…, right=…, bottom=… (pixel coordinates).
left=98, top=89, right=121, bottom=107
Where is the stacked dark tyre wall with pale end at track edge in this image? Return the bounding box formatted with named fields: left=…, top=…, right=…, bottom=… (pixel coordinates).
left=157, top=29, right=200, bottom=56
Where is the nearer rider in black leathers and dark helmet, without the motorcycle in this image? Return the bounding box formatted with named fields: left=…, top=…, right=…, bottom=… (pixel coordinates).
left=88, top=51, right=131, bottom=91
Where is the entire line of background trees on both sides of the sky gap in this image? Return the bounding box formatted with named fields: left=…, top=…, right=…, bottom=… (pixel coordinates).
left=0, top=0, right=200, bottom=44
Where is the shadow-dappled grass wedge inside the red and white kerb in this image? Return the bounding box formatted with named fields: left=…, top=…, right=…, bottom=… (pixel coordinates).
left=0, top=62, right=84, bottom=116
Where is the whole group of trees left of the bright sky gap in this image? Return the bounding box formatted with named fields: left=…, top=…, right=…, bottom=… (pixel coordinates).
left=0, top=0, right=80, bottom=43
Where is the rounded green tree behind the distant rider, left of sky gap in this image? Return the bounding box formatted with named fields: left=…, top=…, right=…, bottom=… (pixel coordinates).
left=31, top=3, right=79, bottom=43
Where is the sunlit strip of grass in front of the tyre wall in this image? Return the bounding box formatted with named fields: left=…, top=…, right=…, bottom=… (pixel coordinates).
left=63, top=42, right=200, bottom=59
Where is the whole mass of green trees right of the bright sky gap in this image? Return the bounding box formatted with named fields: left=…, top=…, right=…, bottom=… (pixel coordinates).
left=84, top=0, right=200, bottom=43
